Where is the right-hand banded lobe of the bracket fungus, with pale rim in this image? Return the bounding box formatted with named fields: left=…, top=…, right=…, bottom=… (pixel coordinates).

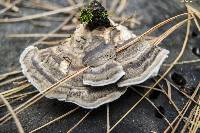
left=117, top=41, right=169, bottom=87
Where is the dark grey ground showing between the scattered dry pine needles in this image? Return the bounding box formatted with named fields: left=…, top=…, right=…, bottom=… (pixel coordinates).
left=0, top=0, right=200, bottom=133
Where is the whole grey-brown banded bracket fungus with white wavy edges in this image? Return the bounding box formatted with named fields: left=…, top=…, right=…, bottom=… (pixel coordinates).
left=20, top=1, right=169, bottom=108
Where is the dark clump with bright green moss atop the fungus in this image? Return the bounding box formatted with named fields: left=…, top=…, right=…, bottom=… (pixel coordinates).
left=80, top=0, right=111, bottom=30
